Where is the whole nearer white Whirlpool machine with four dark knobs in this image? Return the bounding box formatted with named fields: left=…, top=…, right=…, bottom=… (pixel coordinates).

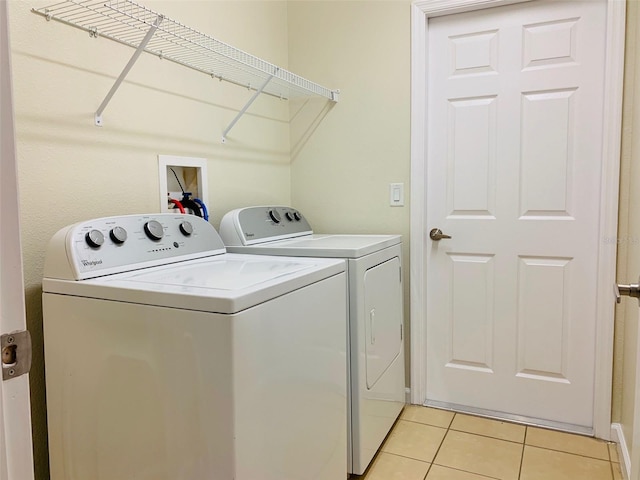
left=43, top=214, right=347, bottom=480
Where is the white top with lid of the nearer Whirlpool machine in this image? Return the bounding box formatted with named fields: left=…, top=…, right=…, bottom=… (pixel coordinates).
left=43, top=254, right=345, bottom=314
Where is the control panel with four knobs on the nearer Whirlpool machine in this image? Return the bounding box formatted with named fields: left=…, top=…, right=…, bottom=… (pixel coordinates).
left=44, top=213, right=226, bottom=280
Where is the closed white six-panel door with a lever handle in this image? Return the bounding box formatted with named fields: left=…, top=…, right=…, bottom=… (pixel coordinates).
left=425, top=1, right=606, bottom=430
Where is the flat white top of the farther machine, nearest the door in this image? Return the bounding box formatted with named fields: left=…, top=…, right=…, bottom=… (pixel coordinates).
left=227, top=234, right=402, bottom=258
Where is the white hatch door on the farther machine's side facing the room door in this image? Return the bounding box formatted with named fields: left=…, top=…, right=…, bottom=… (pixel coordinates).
left=364, top=257, right=402, bottom=389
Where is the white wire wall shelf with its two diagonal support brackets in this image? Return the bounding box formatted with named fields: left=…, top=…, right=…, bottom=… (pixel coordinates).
left=31, top=0, right=340, bottom=142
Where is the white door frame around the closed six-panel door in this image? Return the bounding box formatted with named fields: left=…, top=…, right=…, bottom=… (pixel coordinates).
left=410, top=0, right=626, bottom=440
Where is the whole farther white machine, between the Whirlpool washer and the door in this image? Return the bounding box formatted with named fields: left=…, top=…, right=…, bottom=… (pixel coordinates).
left=220, top=206, right=405, bottom=475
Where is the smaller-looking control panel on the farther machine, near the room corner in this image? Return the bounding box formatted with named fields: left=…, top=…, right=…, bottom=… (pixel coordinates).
left=220, top=206, right=313, bottom=246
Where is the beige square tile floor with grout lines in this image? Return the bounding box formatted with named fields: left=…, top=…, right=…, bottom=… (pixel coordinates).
left=352, top=405, right=623, bottom=480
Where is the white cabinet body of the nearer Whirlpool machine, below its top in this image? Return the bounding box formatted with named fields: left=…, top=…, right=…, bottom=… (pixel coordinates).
left=43, top=268, right=347, bottom=480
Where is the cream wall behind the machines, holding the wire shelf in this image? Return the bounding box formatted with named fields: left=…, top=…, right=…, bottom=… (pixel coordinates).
left=9, top=0, right=291, bottom=479
